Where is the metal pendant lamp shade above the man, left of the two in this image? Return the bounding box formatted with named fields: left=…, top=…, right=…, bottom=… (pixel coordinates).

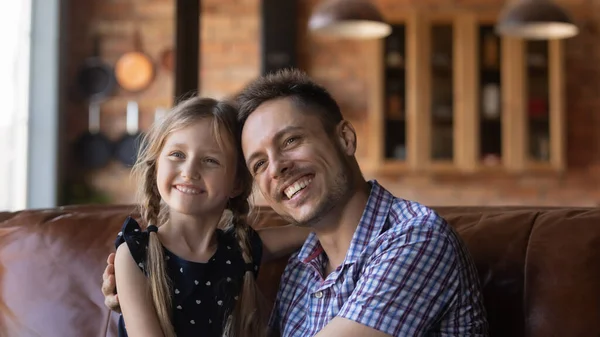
left=308, top=0, right=392, bottom=39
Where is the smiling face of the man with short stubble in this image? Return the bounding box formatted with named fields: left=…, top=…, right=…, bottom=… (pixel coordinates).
left=242, top=98, right=355, bottom=226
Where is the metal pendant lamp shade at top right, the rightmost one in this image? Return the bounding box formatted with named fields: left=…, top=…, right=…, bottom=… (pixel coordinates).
left=496, top=0, right=579, bottom=40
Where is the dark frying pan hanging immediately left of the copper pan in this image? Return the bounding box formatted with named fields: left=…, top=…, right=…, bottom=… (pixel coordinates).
left=76, top=35, right=115, bottom=101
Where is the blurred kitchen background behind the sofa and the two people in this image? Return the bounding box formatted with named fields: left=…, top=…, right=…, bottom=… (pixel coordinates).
left=0, top=0, right=600, bottom=210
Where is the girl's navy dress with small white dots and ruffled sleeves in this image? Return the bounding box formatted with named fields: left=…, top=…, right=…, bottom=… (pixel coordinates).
left=115, top=217, right=262, bottom=337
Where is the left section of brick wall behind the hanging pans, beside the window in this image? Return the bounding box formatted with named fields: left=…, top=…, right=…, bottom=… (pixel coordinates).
left=61, top=0, right=175, bottom=203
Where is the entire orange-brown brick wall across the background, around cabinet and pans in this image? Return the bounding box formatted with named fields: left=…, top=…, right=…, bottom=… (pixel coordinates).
left=67, top=0, right=600, bottom=205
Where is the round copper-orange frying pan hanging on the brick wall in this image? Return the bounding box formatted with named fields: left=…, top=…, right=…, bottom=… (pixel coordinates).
left=115, top=25, right=154, bottom=93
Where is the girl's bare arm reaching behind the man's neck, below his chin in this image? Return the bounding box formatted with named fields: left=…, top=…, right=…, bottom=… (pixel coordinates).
left=256, top=225, right=310, bottom=262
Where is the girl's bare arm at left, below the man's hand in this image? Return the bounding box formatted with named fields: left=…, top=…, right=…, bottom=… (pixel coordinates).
left=115, top=244, right=164, bottom=337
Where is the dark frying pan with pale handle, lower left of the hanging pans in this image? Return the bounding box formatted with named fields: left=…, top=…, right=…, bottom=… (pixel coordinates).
left=75, top=102, right=113, bottom=169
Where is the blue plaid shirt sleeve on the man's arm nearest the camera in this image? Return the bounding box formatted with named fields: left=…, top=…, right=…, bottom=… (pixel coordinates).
left=338, top=219, right=466, bottom=336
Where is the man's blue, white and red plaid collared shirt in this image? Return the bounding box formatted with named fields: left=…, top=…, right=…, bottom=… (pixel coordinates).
left=270, top=181, right=488, bottom=337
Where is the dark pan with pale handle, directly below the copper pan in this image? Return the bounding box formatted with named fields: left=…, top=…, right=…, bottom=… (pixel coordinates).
left=114, top=101, right=142, bottom=167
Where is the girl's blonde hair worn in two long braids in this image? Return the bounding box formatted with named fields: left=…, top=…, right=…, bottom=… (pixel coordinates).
left=132, top=96, right=267, bottom=337
